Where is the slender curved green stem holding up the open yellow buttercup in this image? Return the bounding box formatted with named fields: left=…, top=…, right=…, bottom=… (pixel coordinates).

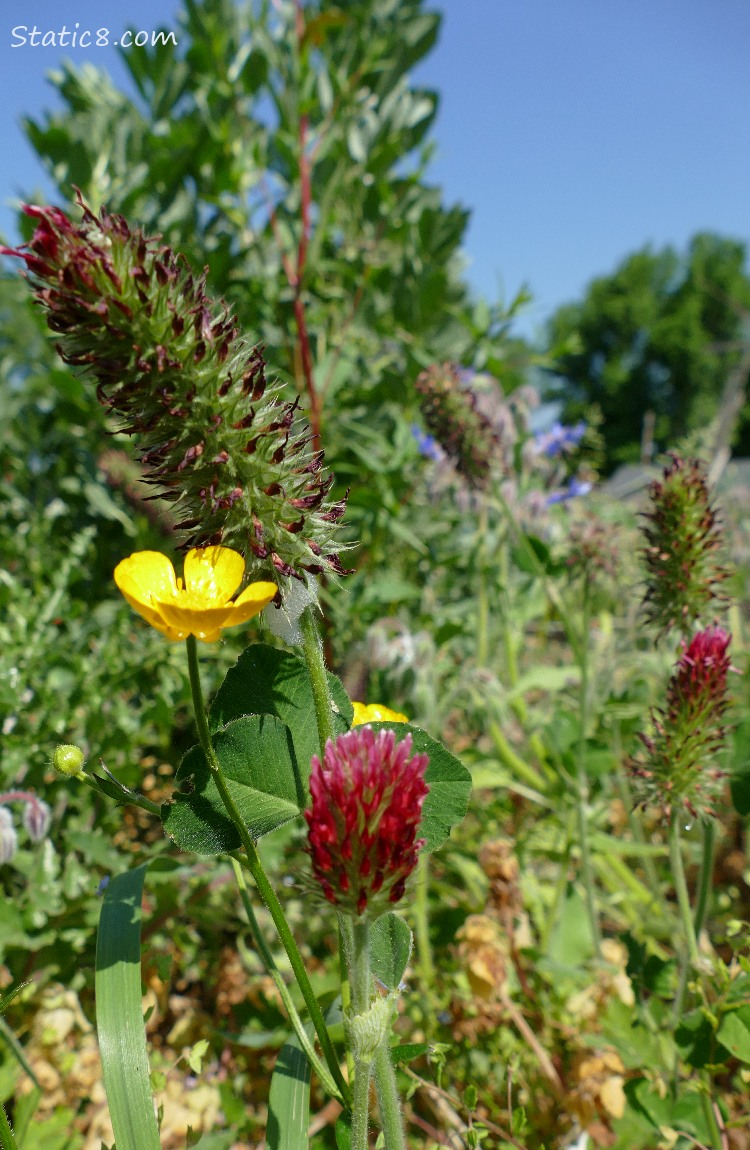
left=186, top=635, right=350, bottom=1098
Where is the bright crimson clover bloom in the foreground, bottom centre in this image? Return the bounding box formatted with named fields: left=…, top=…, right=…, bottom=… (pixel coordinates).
left=305, top=726, right=429, bottom=918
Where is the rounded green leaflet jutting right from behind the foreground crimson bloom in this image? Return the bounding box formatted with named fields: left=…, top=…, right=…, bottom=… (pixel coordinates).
left=370, top=722, right=472, bottom=852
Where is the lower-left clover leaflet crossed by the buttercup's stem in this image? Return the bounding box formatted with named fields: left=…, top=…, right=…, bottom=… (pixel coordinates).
left=162, top=715, right=304, bottom=854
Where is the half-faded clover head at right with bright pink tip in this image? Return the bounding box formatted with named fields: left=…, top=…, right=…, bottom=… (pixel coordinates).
left=629, top=627, right=733, bottom=818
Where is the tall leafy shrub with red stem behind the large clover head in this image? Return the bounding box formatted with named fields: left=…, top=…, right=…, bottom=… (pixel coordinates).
left=20, top=0, right=528, bottom=639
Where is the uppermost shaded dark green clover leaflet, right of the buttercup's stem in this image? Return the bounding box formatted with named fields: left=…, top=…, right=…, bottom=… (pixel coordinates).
left=208, top=643, right=353, bottom=789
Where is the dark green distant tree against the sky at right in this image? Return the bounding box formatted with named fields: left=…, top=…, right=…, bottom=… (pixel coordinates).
left=549, top=233, right=750, bottom=469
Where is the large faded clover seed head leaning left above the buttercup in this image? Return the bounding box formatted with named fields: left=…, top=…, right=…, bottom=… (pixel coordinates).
left=0, top=200, right=346, bottom=585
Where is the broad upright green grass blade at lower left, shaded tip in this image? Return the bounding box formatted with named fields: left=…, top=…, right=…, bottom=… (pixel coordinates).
left=95, top=863, right=160, bottom=1150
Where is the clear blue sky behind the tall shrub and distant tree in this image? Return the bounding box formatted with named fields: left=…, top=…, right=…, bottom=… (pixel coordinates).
left=0, top=0, right=750, bottom=332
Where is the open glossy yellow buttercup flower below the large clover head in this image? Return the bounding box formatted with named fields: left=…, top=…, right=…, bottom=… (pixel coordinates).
left=115, top=546, right=277, bottom=643
